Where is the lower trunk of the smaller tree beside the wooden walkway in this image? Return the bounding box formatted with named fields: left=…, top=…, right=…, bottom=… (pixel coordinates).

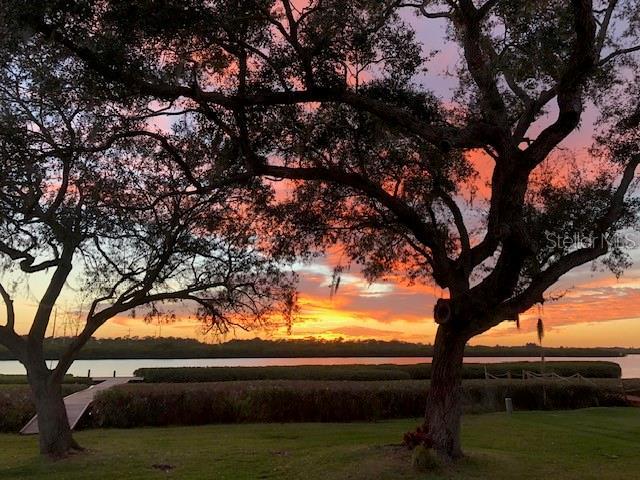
left=29, top=369, right=81, bottom=458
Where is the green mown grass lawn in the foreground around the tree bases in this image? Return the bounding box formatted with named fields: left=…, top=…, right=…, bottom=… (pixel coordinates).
left=0, top=408, right=640, bottom=480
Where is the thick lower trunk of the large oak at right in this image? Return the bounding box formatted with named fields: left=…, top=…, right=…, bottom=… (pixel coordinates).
left=425, top=325, right=467, bottom=461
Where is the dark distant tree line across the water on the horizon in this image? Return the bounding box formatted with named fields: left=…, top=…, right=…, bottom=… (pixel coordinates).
left=0, top=337, right=640, bottom=360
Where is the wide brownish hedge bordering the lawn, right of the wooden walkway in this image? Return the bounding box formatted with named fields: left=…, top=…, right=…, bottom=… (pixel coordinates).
left=85, top=380, right=625, bottom=428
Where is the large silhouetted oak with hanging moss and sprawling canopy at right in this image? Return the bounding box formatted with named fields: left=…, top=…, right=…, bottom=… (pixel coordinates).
left=5, top=0, right=640, bottom=459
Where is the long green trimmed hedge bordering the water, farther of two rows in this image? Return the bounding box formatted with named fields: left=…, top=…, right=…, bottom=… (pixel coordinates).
left=135, top=361, right=621, bottom=383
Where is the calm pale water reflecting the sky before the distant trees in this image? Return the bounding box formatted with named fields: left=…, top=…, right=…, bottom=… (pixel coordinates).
left=0, top=355, right=640, bottom=378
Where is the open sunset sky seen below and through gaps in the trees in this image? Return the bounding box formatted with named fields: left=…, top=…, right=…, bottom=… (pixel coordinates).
left=3, top=7, right=640, bottom=347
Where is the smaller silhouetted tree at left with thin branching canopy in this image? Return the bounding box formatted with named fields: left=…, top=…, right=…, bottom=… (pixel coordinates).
left=0, top=40, right=294, bottom=456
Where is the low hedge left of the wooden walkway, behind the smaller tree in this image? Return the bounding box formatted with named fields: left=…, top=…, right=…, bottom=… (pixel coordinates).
left=0, top=384, right=86, bottom=432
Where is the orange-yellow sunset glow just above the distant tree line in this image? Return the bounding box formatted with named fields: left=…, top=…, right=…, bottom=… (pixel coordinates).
left=28, top=264, right=640, bottom=347
